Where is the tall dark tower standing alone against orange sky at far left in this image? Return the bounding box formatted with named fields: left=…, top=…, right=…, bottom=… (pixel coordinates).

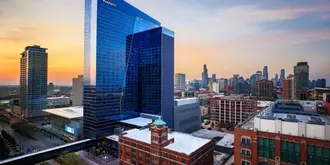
left=20, top=45, right=48, bottom=120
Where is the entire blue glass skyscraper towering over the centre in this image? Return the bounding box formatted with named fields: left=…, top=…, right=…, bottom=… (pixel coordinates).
left=83, top=0, right=174, bottom=138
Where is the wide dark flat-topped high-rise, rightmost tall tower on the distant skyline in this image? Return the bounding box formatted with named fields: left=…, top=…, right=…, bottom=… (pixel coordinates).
left=294, top=62, right=309, bottom=100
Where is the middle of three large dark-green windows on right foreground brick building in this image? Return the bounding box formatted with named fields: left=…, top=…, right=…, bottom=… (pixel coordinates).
left=281, top=140, right=300, bottom=164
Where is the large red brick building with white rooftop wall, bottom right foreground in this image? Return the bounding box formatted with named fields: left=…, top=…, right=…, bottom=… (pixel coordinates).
left=234, top=101, right=330, bottom=165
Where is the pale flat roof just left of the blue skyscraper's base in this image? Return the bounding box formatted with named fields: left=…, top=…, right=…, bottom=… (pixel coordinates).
left=43, top=106, right=84, bottom=119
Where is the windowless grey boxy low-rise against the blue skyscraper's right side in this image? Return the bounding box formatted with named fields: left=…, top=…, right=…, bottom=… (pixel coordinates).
left=174, top=98, right=201, bottom=133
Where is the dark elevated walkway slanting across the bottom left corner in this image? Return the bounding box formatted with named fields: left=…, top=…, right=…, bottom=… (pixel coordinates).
left=0, top=139, right=96, bottom=165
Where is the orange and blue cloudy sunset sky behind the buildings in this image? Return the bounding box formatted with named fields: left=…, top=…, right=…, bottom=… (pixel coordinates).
left=0, top=0, right=330, bottom=85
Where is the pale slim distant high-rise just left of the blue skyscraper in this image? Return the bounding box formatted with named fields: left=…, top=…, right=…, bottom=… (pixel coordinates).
left=71, top=75, right=84, bottom=106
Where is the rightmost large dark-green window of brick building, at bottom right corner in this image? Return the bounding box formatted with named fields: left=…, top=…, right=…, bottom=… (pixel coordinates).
left=307, top=145, right=330, bottom=164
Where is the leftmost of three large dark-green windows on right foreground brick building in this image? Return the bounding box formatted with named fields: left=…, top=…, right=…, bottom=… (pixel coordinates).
left=258, top=138, right=275, bottom=160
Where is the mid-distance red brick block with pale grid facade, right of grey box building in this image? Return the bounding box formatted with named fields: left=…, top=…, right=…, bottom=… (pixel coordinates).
left=210, top=97, right=258, bottom=124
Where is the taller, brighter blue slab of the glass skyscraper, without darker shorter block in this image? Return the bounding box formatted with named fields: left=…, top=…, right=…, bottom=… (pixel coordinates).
left=84, top=0, right=173, bottom=138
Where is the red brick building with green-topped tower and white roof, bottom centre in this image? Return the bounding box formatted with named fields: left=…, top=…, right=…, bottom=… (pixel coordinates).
left=118, top=120, right=214, bottom=165
